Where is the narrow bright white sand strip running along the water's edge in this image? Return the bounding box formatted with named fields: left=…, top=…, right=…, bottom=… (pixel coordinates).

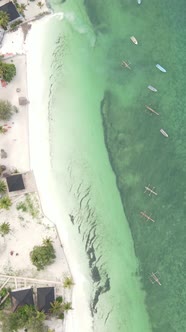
left=27, top=18, right=92, bottom=332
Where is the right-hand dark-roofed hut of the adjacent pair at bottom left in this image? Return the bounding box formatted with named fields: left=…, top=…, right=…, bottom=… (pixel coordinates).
left=37, top=287, right=55, bottom=313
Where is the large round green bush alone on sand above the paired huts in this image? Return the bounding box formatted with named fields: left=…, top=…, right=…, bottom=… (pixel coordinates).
left=30, top=238, right=56, bottom=271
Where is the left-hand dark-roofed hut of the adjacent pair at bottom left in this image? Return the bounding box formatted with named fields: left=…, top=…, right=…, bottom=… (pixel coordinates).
left=10, top=287, right=34, bottom=312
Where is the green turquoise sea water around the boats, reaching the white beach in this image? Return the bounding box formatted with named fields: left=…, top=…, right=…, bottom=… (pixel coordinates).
left=43, top=0, right=186, bottom=332
